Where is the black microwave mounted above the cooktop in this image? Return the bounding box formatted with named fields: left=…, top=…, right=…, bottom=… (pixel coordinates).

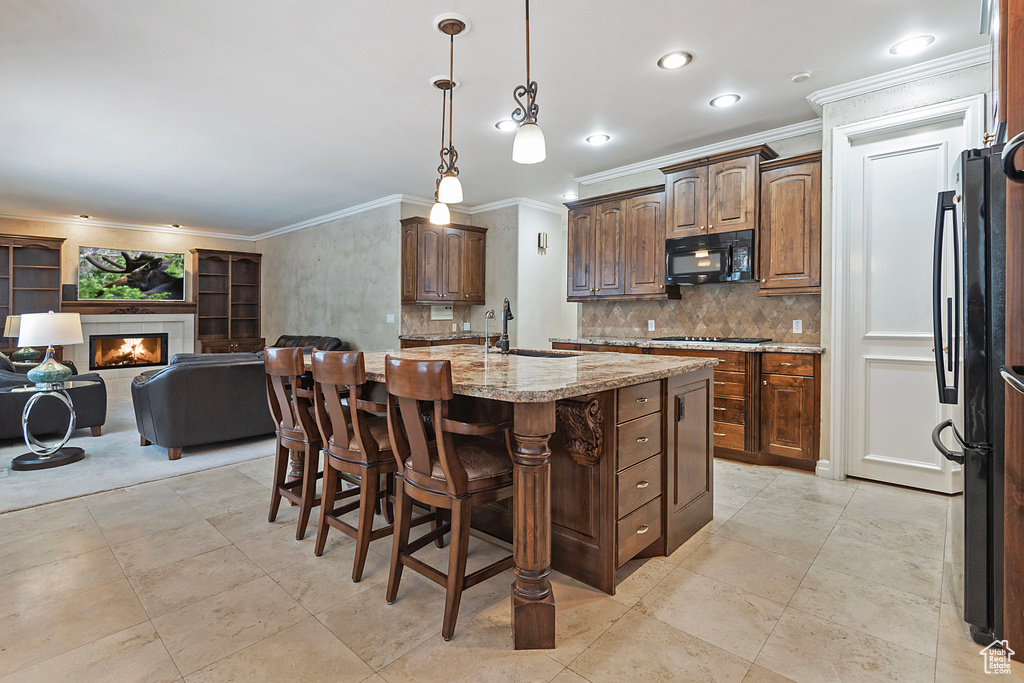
left=665, top=230, right=755, bottom=285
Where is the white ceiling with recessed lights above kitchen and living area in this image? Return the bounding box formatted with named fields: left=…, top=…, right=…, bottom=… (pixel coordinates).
left=0, top=0, right=986, bottom=234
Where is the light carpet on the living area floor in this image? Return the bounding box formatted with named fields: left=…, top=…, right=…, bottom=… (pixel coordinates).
left=0, top=396, right=274, bottom=512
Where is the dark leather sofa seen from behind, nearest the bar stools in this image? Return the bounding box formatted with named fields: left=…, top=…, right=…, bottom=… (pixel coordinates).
left=131, top=353, right=274, bottom=460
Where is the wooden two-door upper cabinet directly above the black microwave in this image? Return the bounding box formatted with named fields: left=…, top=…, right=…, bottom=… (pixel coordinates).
left=662, top=144, right=778, bottom=239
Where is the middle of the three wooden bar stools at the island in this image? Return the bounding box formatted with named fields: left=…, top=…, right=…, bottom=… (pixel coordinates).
left=312, top=351, right=398, bottom=582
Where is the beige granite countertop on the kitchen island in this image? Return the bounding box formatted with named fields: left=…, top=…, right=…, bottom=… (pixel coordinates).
left=364, top=344, right=718, bottom=403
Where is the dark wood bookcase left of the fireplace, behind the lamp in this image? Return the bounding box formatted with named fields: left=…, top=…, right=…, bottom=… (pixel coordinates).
left=0, top=234, right=63, bottom=353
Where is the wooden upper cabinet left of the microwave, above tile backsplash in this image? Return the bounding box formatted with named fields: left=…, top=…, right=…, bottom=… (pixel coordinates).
left=565, top=185, right=679, bottom=301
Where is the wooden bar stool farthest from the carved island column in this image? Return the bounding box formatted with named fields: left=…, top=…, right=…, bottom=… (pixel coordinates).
left=263, top=346, right=323, bottom=541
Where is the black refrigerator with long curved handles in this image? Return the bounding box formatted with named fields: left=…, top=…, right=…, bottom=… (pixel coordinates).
left=932, top=145, right=1007, bottom=645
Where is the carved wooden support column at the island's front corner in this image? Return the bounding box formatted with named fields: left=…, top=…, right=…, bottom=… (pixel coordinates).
left=512, top=401, right=555, bottom=650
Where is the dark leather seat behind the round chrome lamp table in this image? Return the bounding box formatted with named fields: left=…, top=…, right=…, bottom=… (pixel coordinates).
left=0, top=353, right=106, bottom=439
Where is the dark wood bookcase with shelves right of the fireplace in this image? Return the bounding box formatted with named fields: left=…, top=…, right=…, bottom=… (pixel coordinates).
left=189, top=249, right=265, bottom=353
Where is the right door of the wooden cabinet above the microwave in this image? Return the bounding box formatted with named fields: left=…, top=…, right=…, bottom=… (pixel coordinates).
left=708, top=156, right=759, bottom=232
